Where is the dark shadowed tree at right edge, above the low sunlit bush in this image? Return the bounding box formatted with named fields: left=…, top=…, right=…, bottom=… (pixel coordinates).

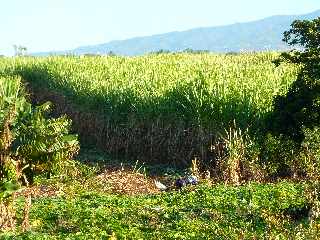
left=270, top=18, right=320, bottom=142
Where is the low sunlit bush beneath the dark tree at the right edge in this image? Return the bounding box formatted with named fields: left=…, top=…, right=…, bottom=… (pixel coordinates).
left=261, top=128, right=320, bottom=180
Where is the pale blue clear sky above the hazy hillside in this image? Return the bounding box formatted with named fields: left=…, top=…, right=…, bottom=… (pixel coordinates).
left=0, top=0, right=320, bottom=55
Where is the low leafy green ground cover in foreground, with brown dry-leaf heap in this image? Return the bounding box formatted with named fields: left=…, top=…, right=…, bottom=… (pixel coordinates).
left=1, top=149, right=320, bottom=239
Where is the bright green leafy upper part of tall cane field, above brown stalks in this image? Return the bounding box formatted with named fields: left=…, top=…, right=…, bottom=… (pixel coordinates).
left=4, top=53, right=296, bottom=127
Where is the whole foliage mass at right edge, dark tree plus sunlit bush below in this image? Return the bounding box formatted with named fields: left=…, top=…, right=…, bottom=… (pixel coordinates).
left=263, top=18, right=320, bottom=177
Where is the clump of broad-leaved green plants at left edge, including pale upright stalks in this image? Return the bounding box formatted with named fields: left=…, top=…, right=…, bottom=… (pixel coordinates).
left=0, top=77, right=79, bottom=187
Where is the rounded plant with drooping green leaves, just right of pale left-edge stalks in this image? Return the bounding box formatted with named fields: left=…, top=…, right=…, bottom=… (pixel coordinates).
left=12, top=102, right=79, bottom=183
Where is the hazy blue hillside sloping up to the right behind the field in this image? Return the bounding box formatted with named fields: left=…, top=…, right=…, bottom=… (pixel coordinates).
left=34, top=10, right=320, bottom=55
